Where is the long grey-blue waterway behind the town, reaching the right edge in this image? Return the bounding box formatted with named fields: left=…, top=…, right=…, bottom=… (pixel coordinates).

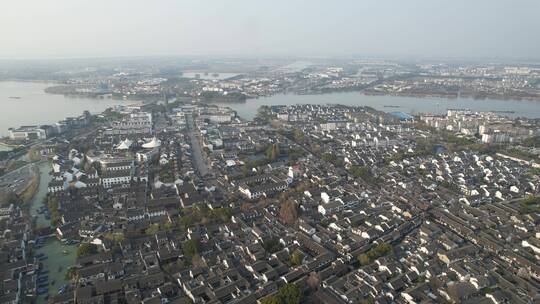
left=212, top=92, right=540, bottom=119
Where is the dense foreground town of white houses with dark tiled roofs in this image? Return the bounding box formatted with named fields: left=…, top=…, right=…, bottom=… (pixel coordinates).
left=0, top=98, right=540, bottom=304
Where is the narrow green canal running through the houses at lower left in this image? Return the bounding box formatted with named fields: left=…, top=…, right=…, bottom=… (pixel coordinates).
left=30, top=161, right=77, bottom=303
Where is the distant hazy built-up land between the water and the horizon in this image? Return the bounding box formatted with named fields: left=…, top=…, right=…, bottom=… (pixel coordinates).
left=4, top=58, right=540, bottom=103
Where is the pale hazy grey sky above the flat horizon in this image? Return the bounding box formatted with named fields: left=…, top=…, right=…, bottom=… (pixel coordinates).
left=0, top=0, right=540, bottom=58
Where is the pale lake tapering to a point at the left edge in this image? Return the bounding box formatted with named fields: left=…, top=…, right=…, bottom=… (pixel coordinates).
left=0, top=81, right=125, bottom=136
